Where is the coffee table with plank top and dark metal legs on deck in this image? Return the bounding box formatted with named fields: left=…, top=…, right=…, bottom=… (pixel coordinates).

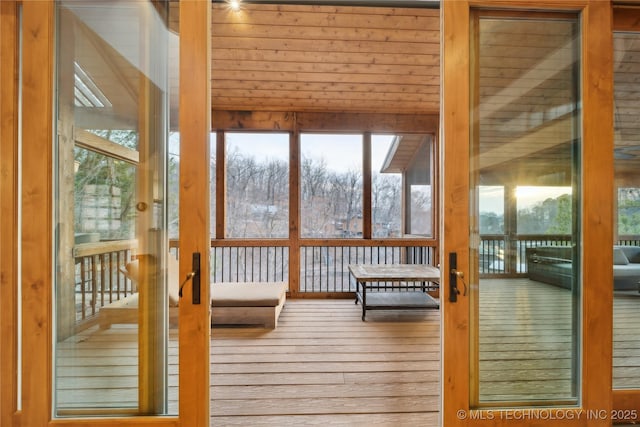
left=349, top=264, right=440, bottom=321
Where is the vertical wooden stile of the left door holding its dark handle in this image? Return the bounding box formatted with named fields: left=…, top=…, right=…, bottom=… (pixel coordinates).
left=179, top=0, right=211, bottom=427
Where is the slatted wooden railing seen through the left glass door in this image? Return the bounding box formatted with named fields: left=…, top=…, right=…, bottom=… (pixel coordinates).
left=74, top=240, right=137, bottom=323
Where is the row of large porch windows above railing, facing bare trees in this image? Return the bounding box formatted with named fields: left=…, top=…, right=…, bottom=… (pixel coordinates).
left=211, top=131, right=435, bottom=244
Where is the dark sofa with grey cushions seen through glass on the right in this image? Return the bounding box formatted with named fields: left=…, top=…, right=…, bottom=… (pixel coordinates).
left=526, top=246, right=640, bottom=291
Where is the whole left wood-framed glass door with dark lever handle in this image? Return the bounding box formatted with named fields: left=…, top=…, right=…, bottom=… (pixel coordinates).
left=16, top=0, right=211, bottom=426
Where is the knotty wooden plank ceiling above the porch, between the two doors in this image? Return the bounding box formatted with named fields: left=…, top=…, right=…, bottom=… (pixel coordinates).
left=211, top=3, right=440, bottom=114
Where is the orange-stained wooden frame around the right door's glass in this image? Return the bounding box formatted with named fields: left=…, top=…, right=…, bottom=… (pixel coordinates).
left=440, top=0, right=613, bottom=427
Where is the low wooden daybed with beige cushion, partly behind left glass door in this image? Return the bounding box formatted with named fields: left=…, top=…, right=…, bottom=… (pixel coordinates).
left=99, top=256, right=288, bottom=328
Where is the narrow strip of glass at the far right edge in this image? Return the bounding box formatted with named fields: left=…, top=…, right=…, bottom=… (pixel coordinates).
left=612, top=33, right=640, bottom=389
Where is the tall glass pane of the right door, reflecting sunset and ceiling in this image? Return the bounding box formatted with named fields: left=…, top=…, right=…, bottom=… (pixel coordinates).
left=470, top=14, right=580, bottom=406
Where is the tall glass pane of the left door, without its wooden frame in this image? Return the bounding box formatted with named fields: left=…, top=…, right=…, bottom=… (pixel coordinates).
left=53, top=1, right=178, bottom=416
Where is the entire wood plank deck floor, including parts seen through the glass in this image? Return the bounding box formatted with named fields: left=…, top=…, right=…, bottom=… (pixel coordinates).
left=56, top=279, right=640, bottom=426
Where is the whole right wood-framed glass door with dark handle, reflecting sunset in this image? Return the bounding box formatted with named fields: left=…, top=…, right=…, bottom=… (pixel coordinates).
left=441, top=1, right=613, bottom=426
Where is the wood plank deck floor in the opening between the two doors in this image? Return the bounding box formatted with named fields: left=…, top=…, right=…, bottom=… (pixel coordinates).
left=205, top=300, right=440, bottom=426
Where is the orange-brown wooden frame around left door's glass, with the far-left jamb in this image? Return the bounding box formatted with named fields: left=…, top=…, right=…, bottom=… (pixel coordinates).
left=11, top=0, right=211, bottom=427
